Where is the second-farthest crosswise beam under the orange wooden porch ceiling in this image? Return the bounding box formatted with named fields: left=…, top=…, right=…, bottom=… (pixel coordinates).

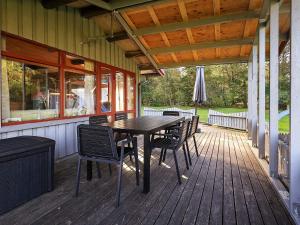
left=148, top=38, right=253, bottom=54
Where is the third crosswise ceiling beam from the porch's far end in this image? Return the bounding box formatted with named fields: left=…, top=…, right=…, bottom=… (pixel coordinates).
left=134, top=11, right=259, bottom=36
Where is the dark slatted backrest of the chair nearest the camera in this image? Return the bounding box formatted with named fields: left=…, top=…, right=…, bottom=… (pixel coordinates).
left=77, top=124, right=119, bottom=160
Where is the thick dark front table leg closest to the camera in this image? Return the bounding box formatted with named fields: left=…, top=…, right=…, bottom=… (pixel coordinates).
left=143, top=134, right=151, bottom=193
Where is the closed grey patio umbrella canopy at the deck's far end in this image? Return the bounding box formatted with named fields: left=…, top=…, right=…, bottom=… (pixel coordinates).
left=193, top=66, right=207, bottom=104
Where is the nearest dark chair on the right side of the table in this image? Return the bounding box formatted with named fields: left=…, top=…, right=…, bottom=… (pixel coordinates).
left=151, top=121, right=189, bottom=184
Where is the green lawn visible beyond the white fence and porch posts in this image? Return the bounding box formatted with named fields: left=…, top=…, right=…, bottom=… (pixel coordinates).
left=142, top=106, right=289, bottom=133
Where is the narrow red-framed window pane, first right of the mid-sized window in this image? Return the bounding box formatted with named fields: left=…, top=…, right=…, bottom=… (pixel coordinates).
left=100, top=67, right=112, bottom=113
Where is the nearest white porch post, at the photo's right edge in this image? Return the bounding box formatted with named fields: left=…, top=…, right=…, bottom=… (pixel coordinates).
left=289, top=0, right=300, bottom=221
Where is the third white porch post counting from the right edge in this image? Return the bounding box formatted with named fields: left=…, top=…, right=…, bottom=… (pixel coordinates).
left=258, top=23, right=266, bottom=158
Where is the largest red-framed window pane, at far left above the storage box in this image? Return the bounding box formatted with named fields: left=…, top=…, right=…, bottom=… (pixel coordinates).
left=2, top=58, right=60, bottom=123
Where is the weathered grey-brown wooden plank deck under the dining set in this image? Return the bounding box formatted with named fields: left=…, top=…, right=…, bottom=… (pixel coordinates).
left=0, top=126, right=293, bottom=225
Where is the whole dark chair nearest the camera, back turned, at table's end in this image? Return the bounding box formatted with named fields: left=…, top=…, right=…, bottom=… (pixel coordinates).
left=75, top=124, right=139, bottom=207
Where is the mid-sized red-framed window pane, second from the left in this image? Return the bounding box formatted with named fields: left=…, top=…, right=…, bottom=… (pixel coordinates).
left=65, top=71, right=96, bottom=116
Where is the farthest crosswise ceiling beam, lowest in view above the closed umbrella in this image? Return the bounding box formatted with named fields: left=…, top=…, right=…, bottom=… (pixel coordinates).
left=158, top=57, right=248, bottom=69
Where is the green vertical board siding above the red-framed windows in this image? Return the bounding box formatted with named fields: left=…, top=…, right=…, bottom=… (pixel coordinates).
left=0, top=0, right=138, bottom=74
